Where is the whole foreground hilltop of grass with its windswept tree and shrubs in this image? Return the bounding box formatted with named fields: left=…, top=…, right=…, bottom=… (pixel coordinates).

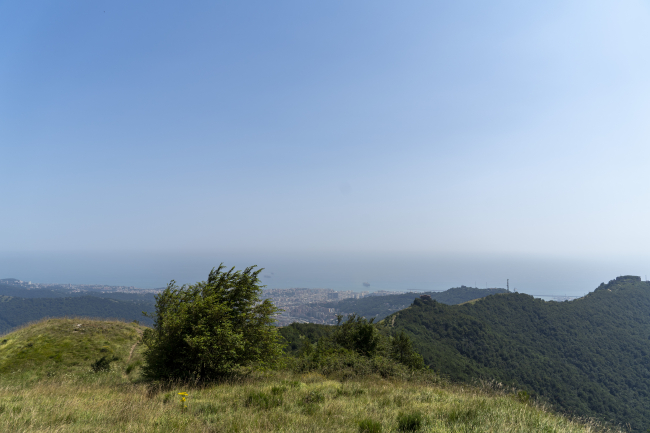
left=0, top=267, right=628, bottom=433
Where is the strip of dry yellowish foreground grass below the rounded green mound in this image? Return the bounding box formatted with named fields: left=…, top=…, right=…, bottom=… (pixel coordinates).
left=0, top=338, right=612, bottom=433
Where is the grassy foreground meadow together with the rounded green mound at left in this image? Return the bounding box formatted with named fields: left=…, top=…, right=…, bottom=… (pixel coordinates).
left=0, top=319, right=616, bottom=433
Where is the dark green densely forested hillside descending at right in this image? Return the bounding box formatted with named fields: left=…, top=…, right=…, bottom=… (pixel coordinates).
left=383, top=277, right=650, bottom=432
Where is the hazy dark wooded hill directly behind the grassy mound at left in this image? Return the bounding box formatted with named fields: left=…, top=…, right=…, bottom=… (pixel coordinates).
left=0, top=295, right=155, bottom=334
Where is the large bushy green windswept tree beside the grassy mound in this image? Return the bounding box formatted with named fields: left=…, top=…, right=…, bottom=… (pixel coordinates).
left=142, top=264, right=282, bottom=380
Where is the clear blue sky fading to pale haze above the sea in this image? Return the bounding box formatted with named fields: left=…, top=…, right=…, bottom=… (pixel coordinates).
left=0, top=1, right=650, bottom=286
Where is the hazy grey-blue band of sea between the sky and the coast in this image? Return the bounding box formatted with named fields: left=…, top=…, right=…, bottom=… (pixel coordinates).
left=0, top=252, right=650, bottom=296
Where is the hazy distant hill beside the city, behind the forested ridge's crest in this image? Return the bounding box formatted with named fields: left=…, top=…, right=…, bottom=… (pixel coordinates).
left=321, top=286, right=507, bottom=321
